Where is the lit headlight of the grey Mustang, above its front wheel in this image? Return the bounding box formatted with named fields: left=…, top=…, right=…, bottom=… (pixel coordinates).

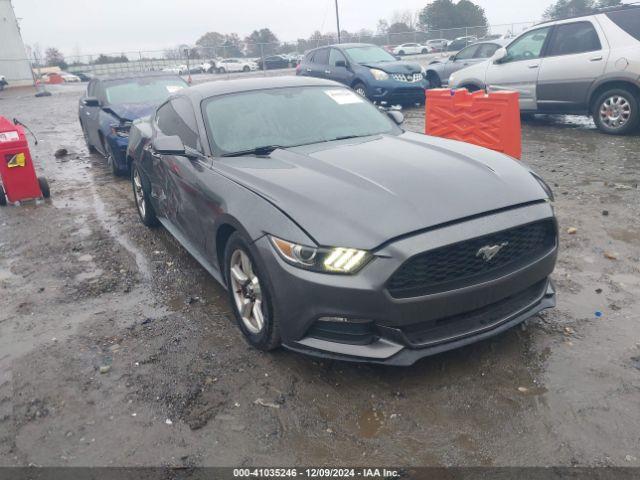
left=269, top=236, right=373, bottom=274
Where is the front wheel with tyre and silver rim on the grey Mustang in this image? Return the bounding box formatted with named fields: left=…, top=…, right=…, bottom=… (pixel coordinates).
left=224, top=232, right=280, bottom=351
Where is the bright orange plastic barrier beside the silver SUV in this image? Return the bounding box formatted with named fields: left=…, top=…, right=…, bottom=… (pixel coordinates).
left=425, top=88, right=522, bottom=159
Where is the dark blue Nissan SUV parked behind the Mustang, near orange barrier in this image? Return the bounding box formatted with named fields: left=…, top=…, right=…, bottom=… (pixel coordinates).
left=296, top=43, right=428, bottom=105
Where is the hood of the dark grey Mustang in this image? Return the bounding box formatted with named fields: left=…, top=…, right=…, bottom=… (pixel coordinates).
left=216, top=133, right=546, bottom=250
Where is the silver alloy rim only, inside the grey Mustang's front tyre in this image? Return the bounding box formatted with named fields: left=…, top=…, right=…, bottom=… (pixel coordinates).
left=229, top=249, right=265, bottom=334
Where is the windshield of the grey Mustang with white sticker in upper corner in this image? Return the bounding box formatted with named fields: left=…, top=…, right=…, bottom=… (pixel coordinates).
left=203, top=86, right=401, bottom=155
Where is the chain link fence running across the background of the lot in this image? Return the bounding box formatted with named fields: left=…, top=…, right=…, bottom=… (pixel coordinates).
left=38, top=22, right=535, bottom=79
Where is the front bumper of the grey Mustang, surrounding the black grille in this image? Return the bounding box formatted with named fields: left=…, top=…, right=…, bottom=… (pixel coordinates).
left=255, top=203, right=557, bottom=365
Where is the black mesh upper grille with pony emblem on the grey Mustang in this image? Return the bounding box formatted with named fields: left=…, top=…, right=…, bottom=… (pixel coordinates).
left=387, top=220, right=557, bottom=298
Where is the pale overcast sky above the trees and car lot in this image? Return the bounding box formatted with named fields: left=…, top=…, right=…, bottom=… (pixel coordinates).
left=13, top=0, right=552, bottom=55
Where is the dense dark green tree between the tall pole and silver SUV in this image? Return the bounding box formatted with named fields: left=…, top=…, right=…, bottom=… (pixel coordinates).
left=419, top=0, right=488, bottom=38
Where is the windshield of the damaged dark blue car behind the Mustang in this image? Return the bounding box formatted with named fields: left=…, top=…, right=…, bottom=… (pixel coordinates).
left=105, top=78, right=188, bottom=105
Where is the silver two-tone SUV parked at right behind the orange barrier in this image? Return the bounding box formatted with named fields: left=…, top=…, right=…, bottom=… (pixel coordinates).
left=449, top=5, right=640, bottom=135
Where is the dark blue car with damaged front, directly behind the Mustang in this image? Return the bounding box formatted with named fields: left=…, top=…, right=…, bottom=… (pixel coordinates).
left=78, top=73, right=189, bottom=175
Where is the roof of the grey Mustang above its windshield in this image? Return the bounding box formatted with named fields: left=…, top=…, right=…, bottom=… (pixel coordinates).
left=176, top=76, right=344, bottom=101
